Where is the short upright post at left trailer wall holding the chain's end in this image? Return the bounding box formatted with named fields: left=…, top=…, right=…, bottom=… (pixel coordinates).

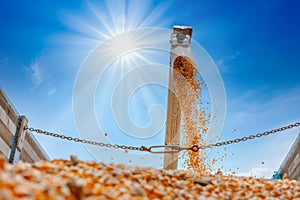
left=8, top=116, right=28, bottom=164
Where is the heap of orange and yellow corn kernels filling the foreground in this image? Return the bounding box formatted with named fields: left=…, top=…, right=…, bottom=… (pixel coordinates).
left=0, top=156, right=300, bottom=200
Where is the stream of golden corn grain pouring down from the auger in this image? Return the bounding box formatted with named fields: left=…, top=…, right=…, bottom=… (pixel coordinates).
left=174, top=56, right=216, bottom=175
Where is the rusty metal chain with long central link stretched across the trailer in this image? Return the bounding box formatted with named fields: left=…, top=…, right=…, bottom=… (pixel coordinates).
left=24, top=122, right=300, bottom=153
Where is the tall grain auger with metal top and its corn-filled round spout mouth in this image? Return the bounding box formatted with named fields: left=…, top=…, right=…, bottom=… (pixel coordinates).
left=164, top=26, right=196, bottom=169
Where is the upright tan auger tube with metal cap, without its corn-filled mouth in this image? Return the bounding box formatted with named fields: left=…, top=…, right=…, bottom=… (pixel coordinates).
left=164, top=26, right=192, bottom=169
